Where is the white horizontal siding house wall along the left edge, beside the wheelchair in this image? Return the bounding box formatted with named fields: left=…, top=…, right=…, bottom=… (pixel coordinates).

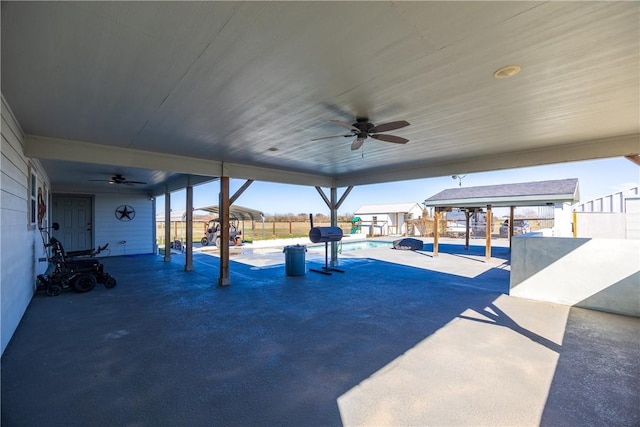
left=0, top=96, right=50, bottom=352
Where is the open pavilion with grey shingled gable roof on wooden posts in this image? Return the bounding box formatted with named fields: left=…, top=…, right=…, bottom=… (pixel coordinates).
left=424, top=178, right=580, bottom=260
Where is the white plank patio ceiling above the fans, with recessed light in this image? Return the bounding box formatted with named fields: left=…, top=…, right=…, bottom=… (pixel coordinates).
left=1, top=1, right=640, bottom=194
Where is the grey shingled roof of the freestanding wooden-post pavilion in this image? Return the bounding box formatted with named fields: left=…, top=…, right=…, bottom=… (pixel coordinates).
left=424, top=178, right=579, bottom=208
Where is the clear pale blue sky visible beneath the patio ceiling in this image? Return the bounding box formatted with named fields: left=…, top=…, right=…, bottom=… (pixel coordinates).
left=156, top=158, right=640, bottom=215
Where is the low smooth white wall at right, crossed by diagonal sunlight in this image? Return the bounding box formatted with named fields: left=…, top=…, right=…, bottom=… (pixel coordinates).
left=510, top=236, right=640, bottom=317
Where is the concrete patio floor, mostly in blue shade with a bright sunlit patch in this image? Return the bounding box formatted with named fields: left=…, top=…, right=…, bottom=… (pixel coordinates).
left=1, top=244, right=640, bottom=426
